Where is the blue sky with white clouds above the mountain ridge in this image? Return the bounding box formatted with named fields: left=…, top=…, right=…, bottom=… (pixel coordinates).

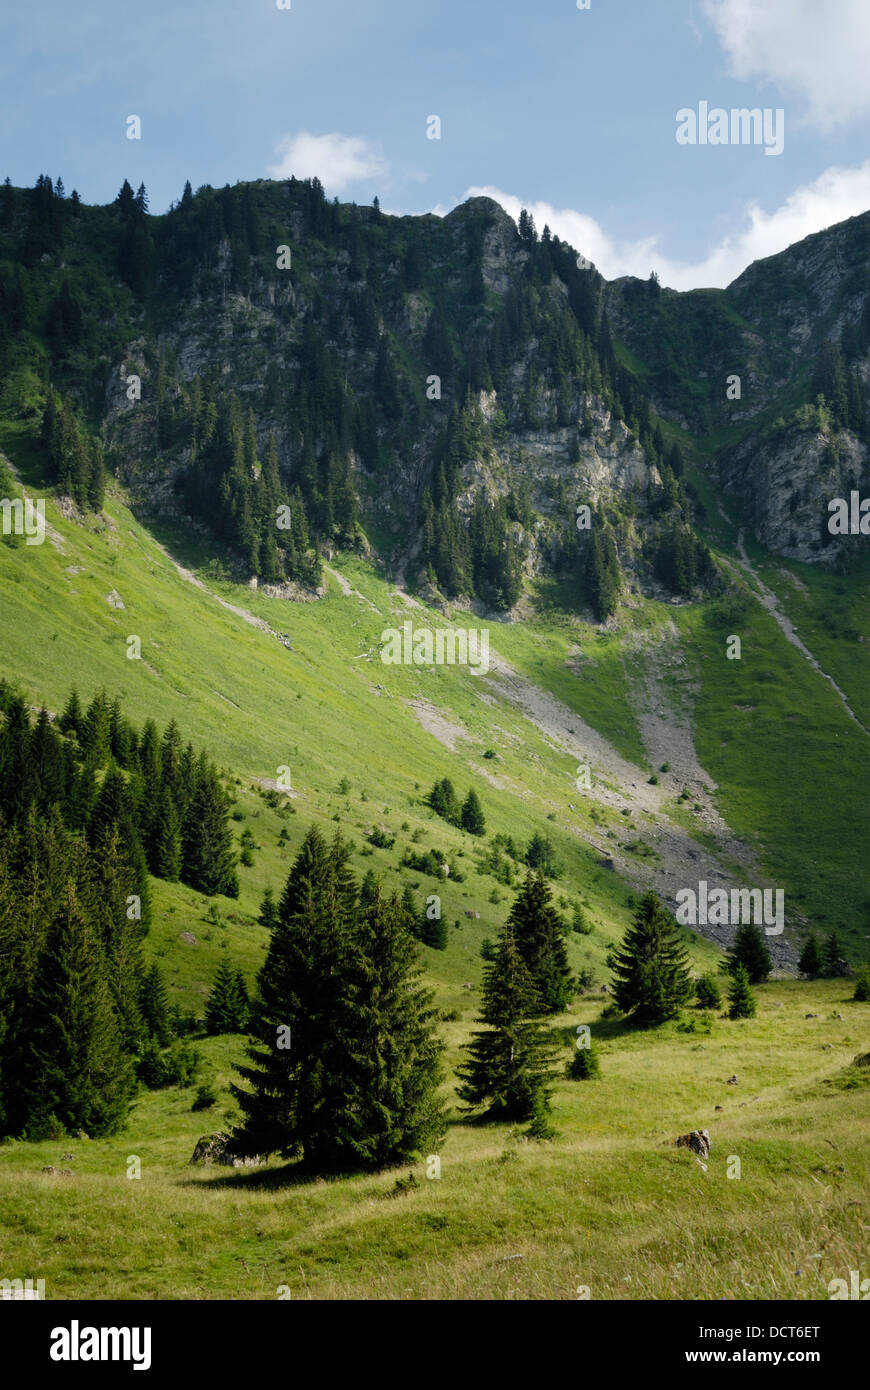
left=0, top=0, right=870, bottom=289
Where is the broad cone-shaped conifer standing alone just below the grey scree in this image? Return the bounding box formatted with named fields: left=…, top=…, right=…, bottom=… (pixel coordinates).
left=613, top=891, right=692, bottom=1024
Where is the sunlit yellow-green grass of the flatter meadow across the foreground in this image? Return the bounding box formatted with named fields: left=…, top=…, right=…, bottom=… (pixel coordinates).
left=0, top=981, right=870, bottom=1300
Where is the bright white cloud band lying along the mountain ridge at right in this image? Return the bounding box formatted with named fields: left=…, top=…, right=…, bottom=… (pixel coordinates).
left=450, top=160, right=870, bottom=289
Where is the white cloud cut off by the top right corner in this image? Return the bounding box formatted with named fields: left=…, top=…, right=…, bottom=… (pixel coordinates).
left=703, top=0, right=870, bottom=131
